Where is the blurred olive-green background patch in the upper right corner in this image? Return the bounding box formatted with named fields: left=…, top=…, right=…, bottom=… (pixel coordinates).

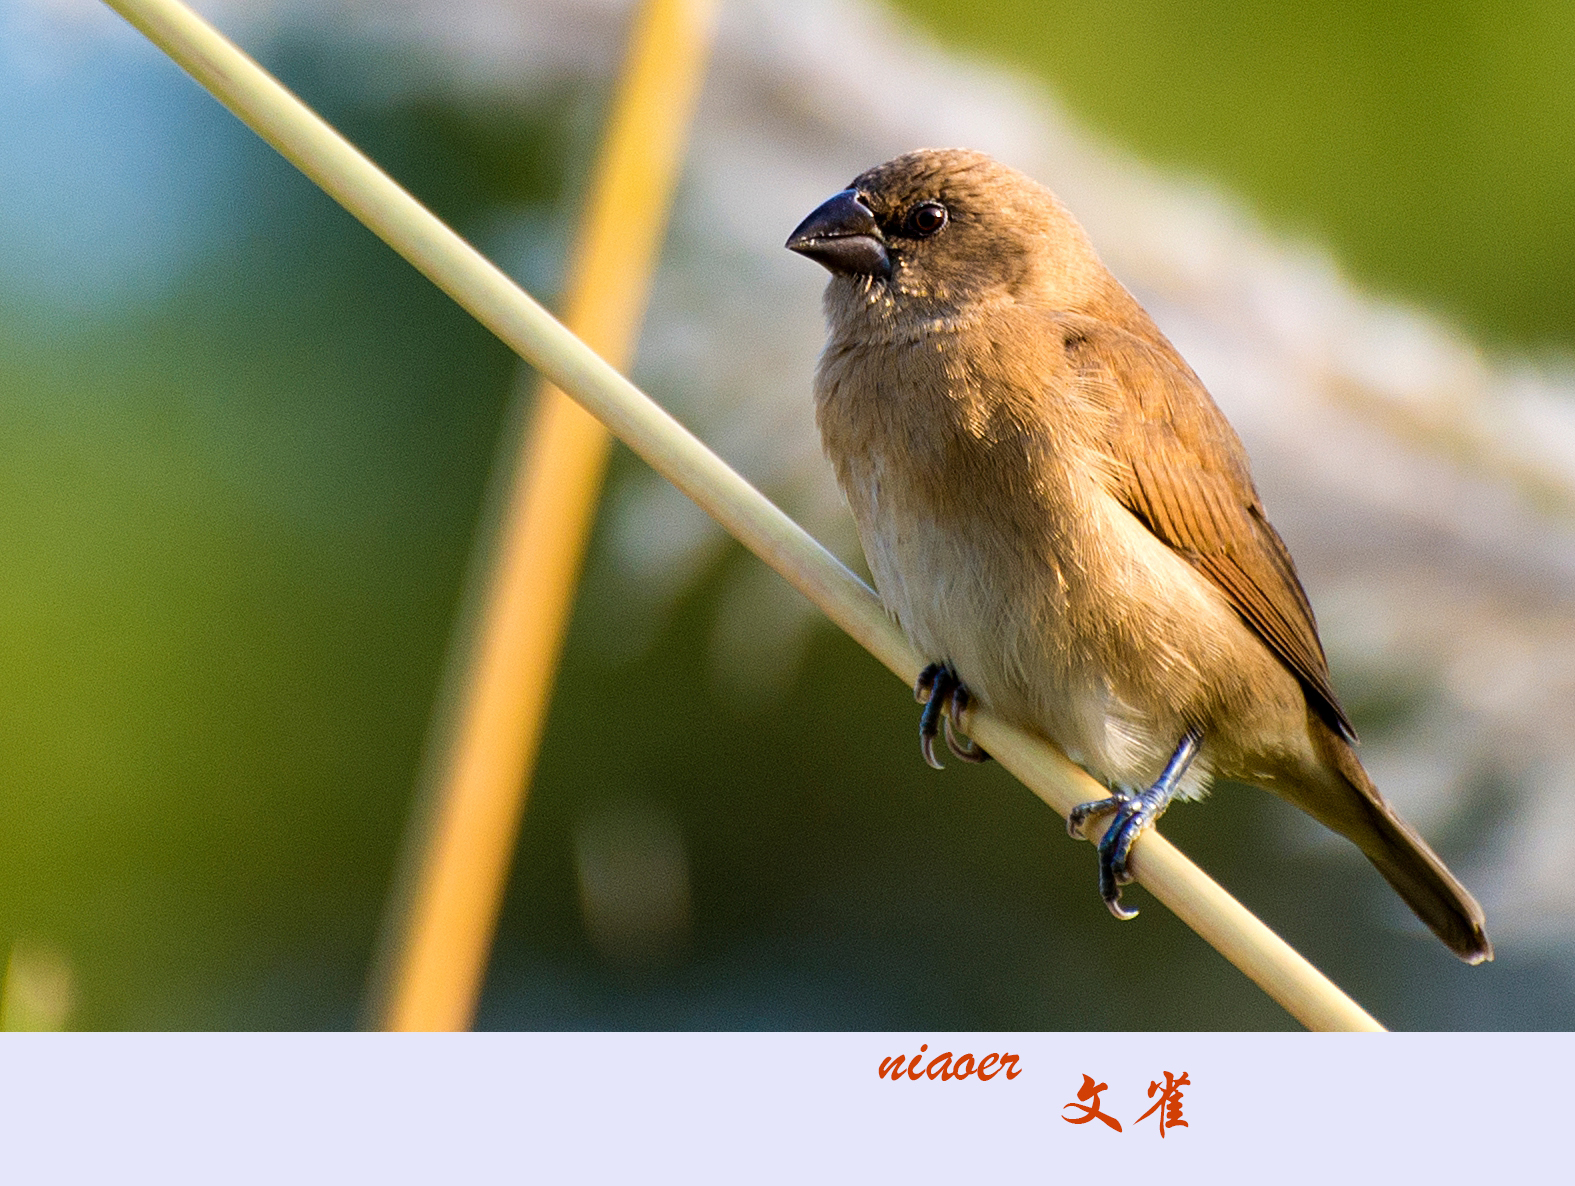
left=899, top=0, right=1575, bottom=354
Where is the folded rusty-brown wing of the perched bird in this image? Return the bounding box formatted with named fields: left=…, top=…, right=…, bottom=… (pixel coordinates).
left=1057, top=317, right=1356, bottom=740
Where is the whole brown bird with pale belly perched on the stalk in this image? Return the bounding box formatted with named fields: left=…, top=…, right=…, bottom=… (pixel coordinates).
left=788, top=150, right=1493, bottom=964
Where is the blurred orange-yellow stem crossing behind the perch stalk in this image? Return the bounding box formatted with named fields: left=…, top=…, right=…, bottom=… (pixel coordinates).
left=372, top=0, right=713, bottom=1030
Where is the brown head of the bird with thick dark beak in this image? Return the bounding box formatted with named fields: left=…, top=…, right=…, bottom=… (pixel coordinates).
left=786, top=148, right=1114, bottom=330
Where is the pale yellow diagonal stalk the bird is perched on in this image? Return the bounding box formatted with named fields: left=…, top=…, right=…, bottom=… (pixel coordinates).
left=106, top=0, right=1381, bottom=1030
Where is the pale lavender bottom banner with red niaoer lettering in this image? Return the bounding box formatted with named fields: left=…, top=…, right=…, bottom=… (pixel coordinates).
left=0, top=1033, right=1556, bottom=1186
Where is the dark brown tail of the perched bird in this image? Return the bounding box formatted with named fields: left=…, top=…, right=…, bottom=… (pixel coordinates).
left=1295, top=713, right=1493, bottom=964
